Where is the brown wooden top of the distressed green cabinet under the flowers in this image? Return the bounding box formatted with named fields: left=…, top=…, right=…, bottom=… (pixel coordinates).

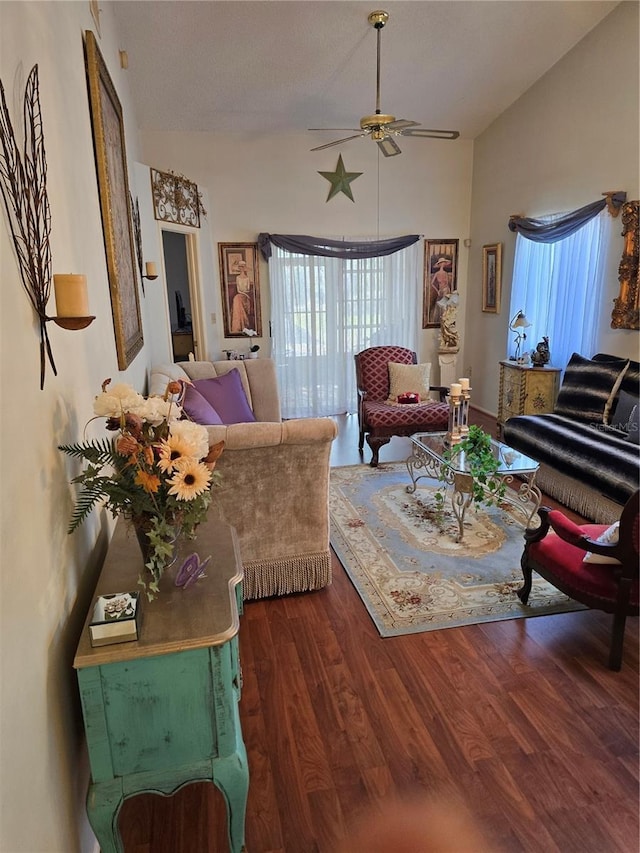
left=73, top=519, right=243, bottom=669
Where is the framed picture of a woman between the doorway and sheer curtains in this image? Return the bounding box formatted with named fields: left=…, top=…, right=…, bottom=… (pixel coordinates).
left=218, top=243, right=262, bottom=338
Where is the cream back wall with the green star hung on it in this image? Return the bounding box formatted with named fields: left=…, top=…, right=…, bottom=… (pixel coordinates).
left=141, top=132, right=473, bottom=364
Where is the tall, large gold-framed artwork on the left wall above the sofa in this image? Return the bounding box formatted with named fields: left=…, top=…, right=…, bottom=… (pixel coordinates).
left=85, top=30, right=143, bottom=370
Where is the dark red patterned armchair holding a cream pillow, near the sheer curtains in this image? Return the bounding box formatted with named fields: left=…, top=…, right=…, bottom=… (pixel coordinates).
left=354, top=346, right=449, bottom=468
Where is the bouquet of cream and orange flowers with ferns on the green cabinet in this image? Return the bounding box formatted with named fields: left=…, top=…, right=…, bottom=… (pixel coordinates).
left=59, top=379, right=224, bottom=599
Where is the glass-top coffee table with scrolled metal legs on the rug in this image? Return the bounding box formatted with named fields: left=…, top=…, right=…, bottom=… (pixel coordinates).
left=406, top=432, right=542, bottom=542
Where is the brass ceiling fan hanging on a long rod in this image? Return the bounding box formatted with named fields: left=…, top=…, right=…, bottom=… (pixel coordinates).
left=309, top=11, right=460, bottom=157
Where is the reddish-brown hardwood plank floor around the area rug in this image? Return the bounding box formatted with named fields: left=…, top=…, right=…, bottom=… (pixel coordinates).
left=120, top=413, right=639, bottom=853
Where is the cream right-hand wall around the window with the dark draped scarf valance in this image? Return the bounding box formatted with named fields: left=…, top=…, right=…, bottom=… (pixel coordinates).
left=463, top=3, right=640, bottom=413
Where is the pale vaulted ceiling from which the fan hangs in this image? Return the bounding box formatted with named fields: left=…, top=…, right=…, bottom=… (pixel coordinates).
left=113, top=0, right=618, bottom=146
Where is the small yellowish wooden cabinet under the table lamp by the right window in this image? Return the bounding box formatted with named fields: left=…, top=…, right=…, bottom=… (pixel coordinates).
left=498, top=361, right=560, bottom=438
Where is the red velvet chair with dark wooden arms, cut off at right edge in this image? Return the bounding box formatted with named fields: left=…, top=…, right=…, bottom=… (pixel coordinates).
left=518, top=492, right=640, bottom=670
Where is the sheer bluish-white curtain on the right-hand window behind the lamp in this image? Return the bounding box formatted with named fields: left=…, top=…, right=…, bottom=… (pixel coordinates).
left=507, top=211, right=612, bottom=367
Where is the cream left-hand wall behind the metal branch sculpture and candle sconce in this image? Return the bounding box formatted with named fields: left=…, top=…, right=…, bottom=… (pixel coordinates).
left=0, top=2, right=146, bottom=853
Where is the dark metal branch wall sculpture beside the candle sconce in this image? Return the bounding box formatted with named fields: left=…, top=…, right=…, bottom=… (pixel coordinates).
left=0, top=65, right=57, bottom=390
